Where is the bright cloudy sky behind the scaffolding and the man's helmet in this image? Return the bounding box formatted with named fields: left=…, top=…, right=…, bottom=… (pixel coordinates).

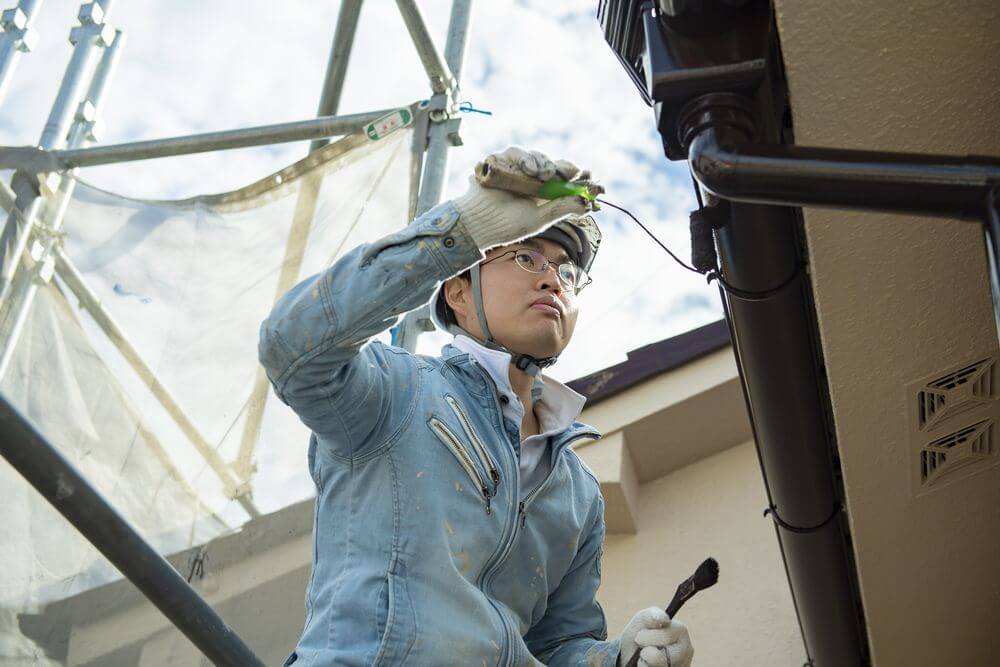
left=0, top=0, right=721, bottom=380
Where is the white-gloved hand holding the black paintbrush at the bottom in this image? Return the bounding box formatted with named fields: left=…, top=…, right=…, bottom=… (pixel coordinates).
left=618, top=607, right=694, bottom=667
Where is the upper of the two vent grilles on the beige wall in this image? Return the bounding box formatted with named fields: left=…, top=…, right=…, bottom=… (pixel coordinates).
left=917, top=359, right=997, bottom=431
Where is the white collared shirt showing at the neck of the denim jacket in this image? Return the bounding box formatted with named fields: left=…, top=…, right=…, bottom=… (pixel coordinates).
left=452, top=336, right=587, bottom=499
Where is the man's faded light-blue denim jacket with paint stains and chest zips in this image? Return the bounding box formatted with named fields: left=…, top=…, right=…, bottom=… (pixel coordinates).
left=260, top=203, right=618, bottom=667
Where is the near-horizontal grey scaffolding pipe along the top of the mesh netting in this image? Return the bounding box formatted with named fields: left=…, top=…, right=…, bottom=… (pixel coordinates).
left=37, top=109, right=396, bottom=168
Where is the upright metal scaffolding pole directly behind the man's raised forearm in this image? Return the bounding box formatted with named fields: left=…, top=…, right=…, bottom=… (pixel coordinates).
left=395, top=0, right=472, bottom=352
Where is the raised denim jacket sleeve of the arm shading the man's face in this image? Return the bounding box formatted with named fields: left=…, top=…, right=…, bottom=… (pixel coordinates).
left=258, top=202, right=482, bottom=458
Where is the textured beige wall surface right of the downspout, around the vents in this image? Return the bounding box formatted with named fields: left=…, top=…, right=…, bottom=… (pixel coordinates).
left=775, top=0, right=1000, bottom=667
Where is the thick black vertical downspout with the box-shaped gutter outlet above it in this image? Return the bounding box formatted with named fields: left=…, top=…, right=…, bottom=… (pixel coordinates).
left=599, top=0, right=870, bottom=667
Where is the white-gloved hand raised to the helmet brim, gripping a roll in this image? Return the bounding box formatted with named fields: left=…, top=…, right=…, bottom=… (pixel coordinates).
left=453, top=146, right=592, bottom=250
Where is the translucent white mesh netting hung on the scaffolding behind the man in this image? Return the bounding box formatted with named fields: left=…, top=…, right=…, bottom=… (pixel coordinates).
left=0, top=115, right=415, bottom=664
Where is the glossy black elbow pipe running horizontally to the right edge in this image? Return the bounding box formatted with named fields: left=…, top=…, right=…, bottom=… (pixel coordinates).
left=678, top=93, right=1000, bottom=222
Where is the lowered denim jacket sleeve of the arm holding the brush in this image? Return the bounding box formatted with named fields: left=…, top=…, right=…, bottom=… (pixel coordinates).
left=524, top=493, right=619, bottom=667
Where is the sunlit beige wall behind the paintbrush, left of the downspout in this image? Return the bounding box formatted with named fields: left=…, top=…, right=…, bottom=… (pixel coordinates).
left=598, top=442, right=805, bottom=667
